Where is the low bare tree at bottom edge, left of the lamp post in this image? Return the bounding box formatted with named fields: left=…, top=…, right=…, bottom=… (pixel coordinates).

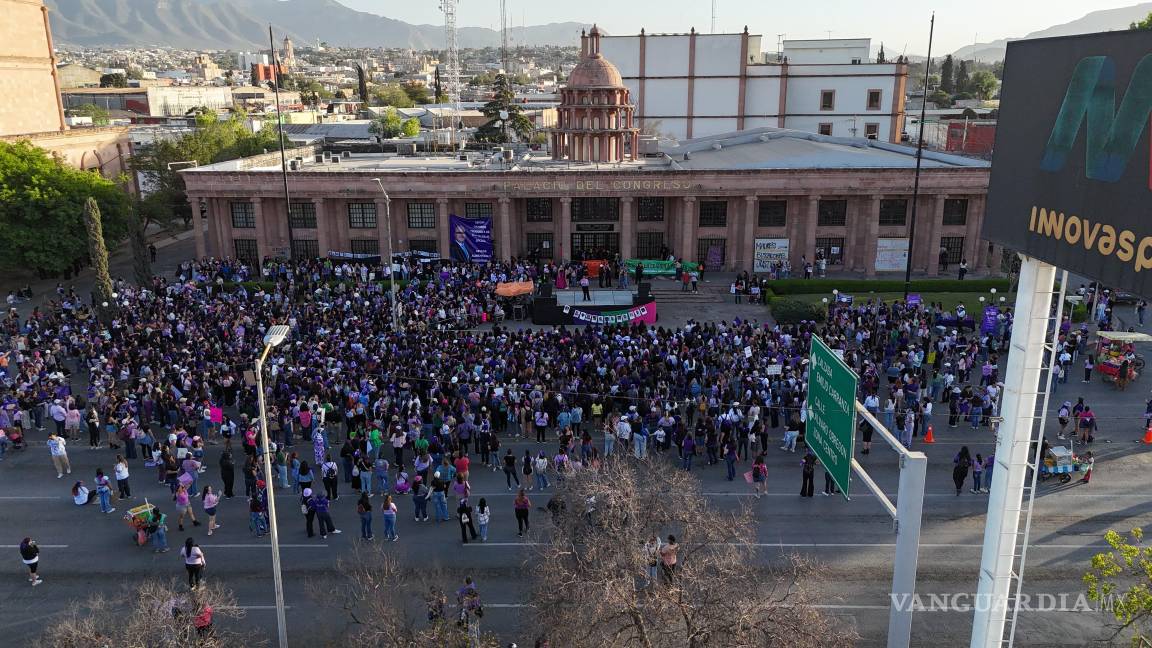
left=39, top=580, right=265, bottom=648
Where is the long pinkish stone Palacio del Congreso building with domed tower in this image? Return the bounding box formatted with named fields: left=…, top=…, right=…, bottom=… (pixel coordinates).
left=183, top=30, right=1000, bottom=276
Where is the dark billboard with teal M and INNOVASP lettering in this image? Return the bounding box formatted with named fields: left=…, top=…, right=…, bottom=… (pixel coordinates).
left=982, top=31, right=1152, bottom=295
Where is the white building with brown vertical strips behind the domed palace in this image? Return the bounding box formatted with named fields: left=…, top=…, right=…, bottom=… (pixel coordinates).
left=601, top=28, right=908, bottom=142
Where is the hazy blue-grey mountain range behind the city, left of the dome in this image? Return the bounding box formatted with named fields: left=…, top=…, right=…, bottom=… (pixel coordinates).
left=45, top=0, right=590, bottom=50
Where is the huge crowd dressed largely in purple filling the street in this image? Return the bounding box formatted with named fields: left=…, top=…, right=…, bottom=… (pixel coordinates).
left=0, top=251, right=1128, bottom=636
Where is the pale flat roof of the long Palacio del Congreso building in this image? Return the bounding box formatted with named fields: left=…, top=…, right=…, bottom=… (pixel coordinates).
left=184, top=126, right=991, bottom=173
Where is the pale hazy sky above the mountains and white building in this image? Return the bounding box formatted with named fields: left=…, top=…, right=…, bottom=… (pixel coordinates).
left=339, top=0, right=1139, bottom=55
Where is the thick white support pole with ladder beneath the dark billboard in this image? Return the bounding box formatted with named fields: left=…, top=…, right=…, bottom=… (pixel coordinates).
left=970, top=255, right=1060, bottom=648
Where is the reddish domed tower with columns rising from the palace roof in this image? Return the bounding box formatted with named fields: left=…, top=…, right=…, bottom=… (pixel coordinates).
left=552, top=25, right=639, bottom=163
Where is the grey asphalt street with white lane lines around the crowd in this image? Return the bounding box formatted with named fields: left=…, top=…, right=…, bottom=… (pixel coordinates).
left=0, top=240, right=1152, bottom=646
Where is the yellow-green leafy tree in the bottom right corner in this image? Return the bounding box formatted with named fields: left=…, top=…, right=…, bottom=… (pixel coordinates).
left=1083, top=527, right=1152, bottom=646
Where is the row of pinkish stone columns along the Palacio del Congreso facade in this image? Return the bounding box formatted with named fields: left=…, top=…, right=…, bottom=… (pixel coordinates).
left=189, top=194, right=999, bottom=276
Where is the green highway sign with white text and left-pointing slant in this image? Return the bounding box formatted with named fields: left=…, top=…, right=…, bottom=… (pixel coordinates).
left=804, top=336, right=859, bottom=498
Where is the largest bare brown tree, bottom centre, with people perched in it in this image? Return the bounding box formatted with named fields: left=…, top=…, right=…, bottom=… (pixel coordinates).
left=532, top=460, right=856, bottom=648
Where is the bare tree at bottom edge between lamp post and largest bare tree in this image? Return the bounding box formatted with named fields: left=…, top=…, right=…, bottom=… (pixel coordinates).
left=324, top=548, right=500, bottom=648
